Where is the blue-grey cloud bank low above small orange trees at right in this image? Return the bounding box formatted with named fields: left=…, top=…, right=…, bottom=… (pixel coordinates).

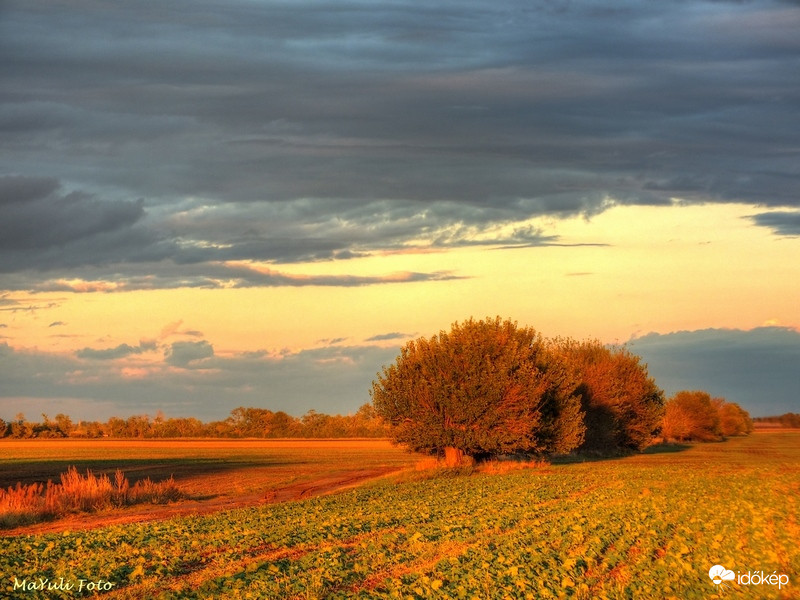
left=628, top=327, right=800, bottom=416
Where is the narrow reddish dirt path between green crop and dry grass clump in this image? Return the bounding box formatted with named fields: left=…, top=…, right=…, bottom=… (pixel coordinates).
left=0, top=467, right=400, bottom=536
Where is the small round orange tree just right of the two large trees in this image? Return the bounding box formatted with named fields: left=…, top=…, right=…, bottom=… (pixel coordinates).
left=662, top=391, right=720, bottom=442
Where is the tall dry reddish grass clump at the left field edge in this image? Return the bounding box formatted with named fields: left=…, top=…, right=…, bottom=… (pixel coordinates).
left=0, top=467, right=184, bottom=527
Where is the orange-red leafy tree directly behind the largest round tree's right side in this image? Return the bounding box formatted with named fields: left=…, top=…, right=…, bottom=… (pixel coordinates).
left=553, top=339, right=664, bottom=452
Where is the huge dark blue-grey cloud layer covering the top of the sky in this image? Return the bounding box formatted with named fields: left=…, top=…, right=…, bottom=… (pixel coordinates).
left=0, top=0, right=800, bottom=289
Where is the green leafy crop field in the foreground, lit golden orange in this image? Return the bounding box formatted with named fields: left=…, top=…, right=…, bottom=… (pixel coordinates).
left=0, top=433, right=800, bottom=600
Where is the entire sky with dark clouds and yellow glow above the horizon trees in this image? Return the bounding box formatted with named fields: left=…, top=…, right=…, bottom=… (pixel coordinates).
left=0, top=0, right=800, bottom=420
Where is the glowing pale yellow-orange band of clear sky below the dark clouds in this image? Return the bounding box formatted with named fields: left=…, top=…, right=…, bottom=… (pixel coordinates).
left=4, top=205, right=800, bottom=354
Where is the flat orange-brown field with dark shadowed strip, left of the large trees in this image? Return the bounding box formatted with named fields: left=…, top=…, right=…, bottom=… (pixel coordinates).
left=0, top=439, right=412, bottom=533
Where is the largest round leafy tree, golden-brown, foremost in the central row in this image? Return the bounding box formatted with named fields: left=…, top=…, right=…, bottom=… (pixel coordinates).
left=371, top=317, right=584, bottom=463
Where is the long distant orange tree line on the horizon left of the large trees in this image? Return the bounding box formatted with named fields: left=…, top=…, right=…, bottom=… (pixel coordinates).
left=0, top=404, right=388, bottom=439
